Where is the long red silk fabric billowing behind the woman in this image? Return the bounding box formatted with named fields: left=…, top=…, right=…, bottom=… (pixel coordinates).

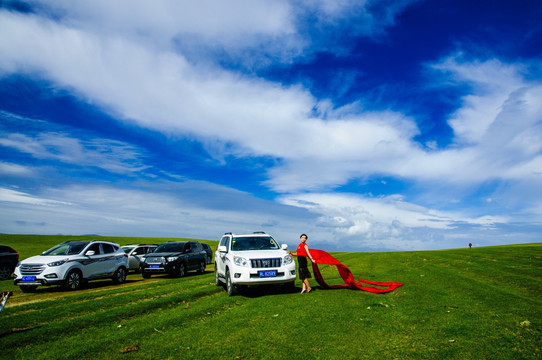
left=309, top=249, right=403, bottom=294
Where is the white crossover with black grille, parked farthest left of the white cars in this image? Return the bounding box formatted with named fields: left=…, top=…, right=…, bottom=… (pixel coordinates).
left=14, top=240, right=128, bottom=292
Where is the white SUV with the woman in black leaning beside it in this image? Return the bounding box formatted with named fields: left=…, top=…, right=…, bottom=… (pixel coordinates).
left=215, top=232, right=296, bottom=296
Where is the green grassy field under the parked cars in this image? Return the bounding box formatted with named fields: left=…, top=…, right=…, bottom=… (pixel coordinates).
left=0, top=235, right=542, bottom=359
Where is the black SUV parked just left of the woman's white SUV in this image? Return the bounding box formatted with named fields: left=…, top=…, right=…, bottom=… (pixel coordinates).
left=140, top=241, right=207, bottom=279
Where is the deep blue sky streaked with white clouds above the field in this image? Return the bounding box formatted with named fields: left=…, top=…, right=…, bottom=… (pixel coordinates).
left=0, top=0, right=542, bottom=251
